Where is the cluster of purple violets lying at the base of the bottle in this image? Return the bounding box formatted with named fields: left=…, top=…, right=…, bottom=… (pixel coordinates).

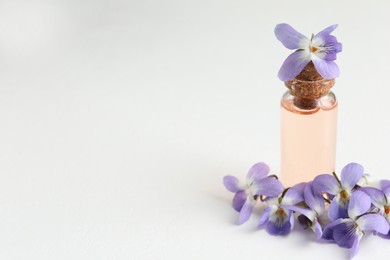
left=223, top=163, right=390, bottom=258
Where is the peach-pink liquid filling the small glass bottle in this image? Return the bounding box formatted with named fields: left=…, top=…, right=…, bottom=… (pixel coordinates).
left=281, top=101, right=337, bottom=187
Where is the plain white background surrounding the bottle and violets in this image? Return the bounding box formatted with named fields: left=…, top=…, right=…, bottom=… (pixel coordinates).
left=0, top=0, right=390, bottom=260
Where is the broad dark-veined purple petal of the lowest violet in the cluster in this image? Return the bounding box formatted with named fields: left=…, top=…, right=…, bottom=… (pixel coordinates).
left=333, top=220, right=359, bottom=248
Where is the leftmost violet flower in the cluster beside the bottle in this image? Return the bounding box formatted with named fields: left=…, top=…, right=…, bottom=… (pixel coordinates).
left=223, top=163, right=283, bottom=224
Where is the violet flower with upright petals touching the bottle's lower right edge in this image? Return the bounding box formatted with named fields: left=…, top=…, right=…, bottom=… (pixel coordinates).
left=313, top=163, right=364, bottom=221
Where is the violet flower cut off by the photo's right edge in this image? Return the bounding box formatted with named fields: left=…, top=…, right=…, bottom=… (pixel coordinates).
left=360, top=186, right=390, bottom=239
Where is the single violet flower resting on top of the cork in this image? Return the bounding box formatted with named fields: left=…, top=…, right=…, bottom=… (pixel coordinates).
left=275, top=23, right=342, bottom=81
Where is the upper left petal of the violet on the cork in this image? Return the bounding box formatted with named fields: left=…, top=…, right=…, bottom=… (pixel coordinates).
left=274, top=23, right=309, bottom=50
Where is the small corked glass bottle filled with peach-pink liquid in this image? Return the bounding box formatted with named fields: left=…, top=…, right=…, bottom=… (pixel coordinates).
left=281, top=62, right=337, bottom=187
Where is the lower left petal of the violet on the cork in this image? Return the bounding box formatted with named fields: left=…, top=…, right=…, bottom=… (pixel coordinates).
left=278, top=50, right=310, bottom=81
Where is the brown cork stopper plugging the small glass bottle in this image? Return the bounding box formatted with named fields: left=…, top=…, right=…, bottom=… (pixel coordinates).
left=284, top=62, right=335, bottom=109
